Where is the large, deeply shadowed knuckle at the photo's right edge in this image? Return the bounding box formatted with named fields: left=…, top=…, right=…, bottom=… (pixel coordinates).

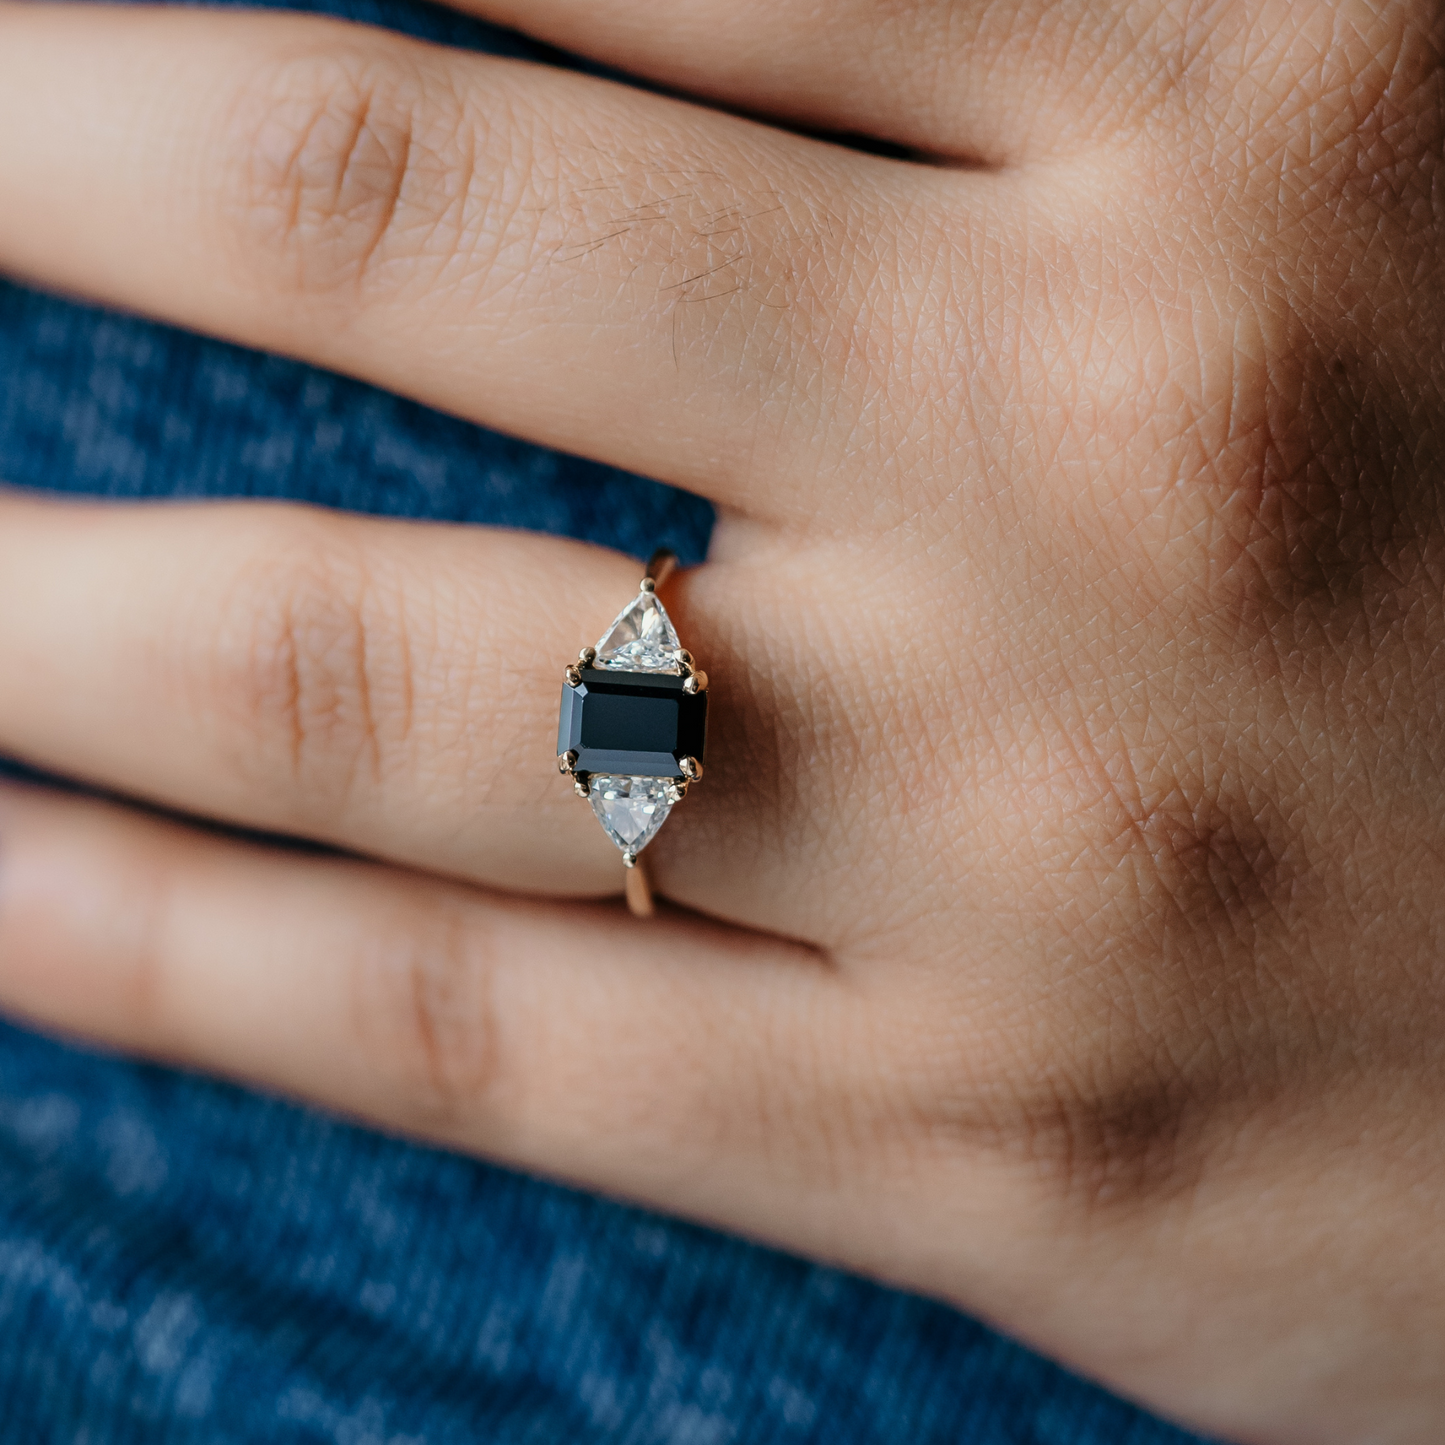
left=1075, top=293, right=1441, bottom=636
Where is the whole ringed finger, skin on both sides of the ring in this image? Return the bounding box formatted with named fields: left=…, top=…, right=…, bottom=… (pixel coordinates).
left=0, top=494, right=855, bottom=944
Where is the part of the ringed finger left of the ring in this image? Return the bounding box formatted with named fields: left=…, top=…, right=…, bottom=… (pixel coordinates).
left=0, top=497, right=719, bottom=896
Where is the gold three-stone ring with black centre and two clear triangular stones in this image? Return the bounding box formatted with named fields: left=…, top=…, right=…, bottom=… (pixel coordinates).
left=556, top=549, right=708, bottom=918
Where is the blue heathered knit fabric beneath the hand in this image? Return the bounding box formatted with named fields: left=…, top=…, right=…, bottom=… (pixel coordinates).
left=0, top=0, right=1219, bottom=1445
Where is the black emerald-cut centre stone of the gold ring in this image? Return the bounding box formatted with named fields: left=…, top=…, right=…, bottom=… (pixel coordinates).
left=556, top=668, right=708, bottom=777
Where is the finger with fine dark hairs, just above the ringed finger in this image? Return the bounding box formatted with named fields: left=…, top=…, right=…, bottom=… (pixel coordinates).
left=0, top=4, right=924, bottom=517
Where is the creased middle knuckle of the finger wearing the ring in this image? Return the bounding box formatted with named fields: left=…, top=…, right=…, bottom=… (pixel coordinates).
left=208, top=530, right=410, bottom=814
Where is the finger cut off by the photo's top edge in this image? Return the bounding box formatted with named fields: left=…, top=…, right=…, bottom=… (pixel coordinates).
left=462, top=0, right=1161, bottom=165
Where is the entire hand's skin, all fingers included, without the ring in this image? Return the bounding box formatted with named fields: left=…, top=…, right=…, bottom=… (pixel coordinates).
left=0, top=0, right=1445, bottom=1445
